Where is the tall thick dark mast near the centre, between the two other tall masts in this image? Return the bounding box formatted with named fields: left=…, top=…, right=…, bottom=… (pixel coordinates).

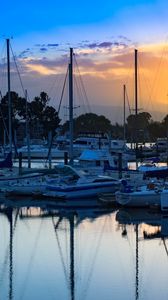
left=69, top=48, right=73, bottom=165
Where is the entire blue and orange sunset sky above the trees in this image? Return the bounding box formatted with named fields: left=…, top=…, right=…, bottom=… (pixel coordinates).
left=0, top=0, right=168, bottom=123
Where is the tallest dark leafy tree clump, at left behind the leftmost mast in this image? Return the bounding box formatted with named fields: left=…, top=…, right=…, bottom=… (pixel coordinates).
left=0, top=91, right=60, bottom=141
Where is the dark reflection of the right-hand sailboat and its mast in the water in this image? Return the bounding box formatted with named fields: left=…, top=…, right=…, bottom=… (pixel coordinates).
left=116, top=208, right=168, bottom=300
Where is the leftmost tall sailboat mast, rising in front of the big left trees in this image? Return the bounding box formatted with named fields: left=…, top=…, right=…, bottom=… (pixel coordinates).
left=6, top=39, right=12, bottom=152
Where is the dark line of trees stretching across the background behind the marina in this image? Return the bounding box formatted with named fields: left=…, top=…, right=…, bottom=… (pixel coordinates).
left=0, top=91, right=168, bottom=142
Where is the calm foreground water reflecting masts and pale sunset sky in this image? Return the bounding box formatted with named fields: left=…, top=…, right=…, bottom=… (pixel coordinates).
left=0, top=201, right=168, bottom=300
